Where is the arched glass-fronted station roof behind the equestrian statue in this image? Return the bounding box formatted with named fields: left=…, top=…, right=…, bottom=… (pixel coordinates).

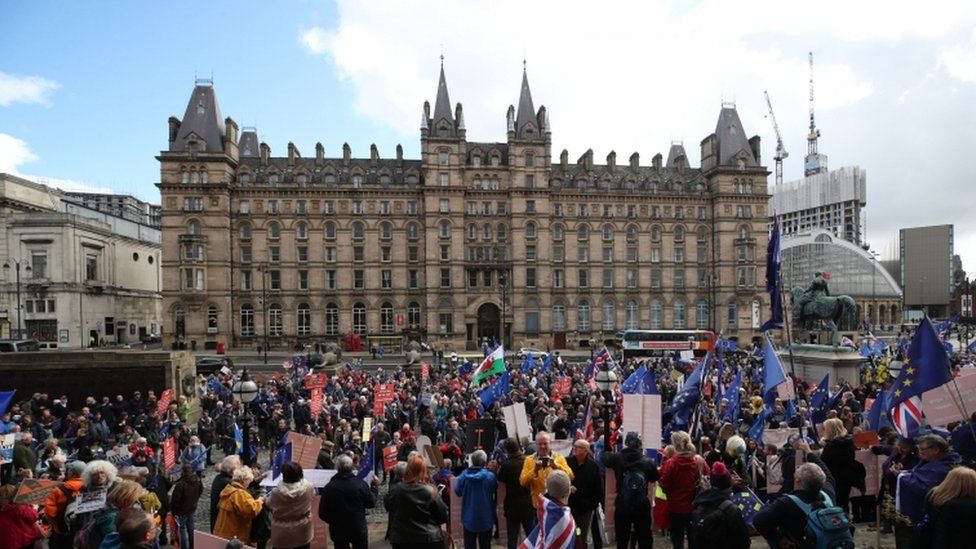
left=781, top=230, right=902, bottom=326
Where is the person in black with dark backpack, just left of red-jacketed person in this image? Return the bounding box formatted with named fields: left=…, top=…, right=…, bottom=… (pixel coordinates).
left=600, top=432, right=660, bottom=549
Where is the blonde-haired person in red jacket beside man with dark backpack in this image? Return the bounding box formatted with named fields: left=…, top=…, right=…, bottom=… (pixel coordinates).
left=661, top=431, right=708, bottom=549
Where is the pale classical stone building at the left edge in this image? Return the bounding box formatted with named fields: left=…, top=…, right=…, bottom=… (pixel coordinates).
left=0, top=174, right=162, bottom=349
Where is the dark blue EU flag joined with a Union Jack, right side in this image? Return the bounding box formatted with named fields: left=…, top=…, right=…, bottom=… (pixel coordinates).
left=890, top=317, right=952, bottom=436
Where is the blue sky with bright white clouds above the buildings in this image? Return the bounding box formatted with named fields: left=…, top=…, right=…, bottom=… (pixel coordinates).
left=0, top=0, right=976, bottom=271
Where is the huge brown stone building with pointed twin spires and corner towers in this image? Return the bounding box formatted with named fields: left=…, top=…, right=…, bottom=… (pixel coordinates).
left=158, top=67, right=769, bottom=350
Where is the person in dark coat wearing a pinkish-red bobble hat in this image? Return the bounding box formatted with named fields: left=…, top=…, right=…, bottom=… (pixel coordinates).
left=688, top=460, right=751, bottom=549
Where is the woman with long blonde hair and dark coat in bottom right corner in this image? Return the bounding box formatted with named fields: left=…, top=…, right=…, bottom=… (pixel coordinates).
left=914, top=467, right=976, bottom=549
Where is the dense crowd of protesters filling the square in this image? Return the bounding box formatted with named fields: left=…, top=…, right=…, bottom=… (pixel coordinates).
left=0, top=330, right=976, bottom=549
